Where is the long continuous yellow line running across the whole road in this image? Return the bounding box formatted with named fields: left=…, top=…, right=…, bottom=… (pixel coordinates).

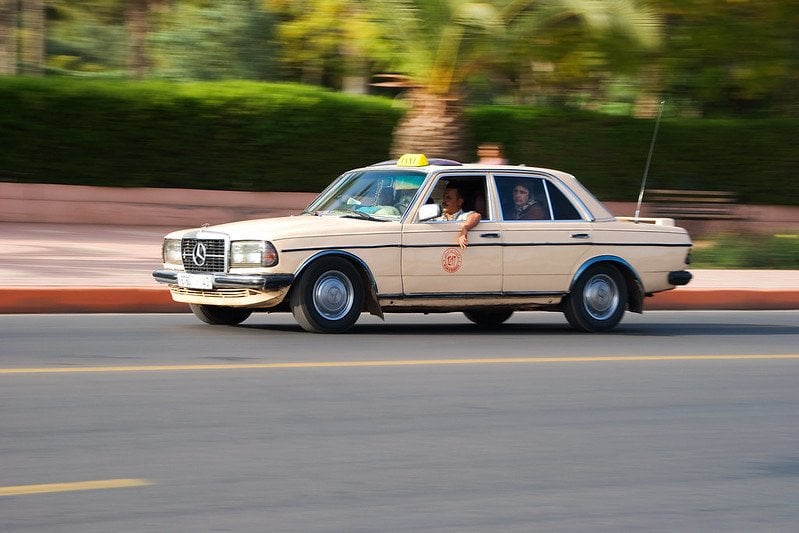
left=0, top=354, right=799, bottom=376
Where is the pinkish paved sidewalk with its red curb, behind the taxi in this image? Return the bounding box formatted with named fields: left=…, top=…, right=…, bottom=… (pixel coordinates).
left=0, top=222, right=799, bottom=314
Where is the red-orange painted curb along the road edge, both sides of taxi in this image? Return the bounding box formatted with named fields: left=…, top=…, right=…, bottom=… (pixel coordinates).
left=0, top=287, right=799, bottom=314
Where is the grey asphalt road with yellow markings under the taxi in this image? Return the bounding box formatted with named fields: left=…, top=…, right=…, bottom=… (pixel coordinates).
left=0, top=311, right=799, bottom=532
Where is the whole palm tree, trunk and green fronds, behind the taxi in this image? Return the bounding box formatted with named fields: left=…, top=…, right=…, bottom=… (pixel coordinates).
left=366, top=0, right=660, bottom=160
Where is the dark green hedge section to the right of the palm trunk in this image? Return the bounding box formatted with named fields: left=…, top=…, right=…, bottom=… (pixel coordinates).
left=470, top=107, right=799, bottom=205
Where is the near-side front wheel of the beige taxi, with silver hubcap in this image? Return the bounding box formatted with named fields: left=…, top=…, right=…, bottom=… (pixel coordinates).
left=290, top=257, right=364, bottom=333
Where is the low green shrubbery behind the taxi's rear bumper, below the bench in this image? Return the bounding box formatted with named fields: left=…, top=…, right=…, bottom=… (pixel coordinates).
left=691, top=234, right=799, bottom=270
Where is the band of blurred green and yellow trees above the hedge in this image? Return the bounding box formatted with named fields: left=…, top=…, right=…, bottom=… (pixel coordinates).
left=17, top=0, right=799, bottom=117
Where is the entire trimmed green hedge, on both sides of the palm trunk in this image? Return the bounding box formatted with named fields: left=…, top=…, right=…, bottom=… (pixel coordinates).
left=0, top=78, right=799, bottom=205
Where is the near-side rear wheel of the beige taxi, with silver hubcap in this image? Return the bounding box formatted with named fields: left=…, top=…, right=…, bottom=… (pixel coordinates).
left=563, top=265, right=627, bottom=333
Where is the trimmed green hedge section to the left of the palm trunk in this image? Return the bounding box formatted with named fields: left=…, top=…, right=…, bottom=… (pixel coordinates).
left=0, top=78, right=404, bottom=191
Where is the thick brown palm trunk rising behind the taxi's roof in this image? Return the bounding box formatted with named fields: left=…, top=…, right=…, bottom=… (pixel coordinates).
left=391, top=89, right=475, bottom=162
